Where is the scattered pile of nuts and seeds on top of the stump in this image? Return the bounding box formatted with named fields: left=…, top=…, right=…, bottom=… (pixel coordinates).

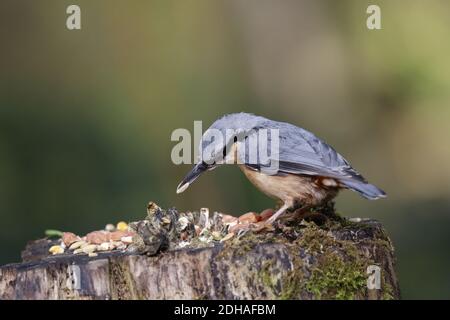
left=39, top=202, right=342, bottom=257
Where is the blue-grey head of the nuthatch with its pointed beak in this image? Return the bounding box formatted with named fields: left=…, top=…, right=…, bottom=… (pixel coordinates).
left=177, top=113, right=266, bottom=193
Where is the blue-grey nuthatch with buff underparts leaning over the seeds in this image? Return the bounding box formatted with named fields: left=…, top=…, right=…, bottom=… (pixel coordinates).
left=177, top=112, right=386, bottom=224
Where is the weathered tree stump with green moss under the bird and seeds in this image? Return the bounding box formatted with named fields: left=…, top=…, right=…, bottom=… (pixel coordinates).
left=0, top=209, right=400, bottom=299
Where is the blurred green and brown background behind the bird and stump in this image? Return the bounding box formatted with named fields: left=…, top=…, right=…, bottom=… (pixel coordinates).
left=0, top=0, right=450, bottom=298
